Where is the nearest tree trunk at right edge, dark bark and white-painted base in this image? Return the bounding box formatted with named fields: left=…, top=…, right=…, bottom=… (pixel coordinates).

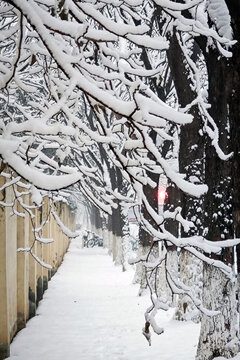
left=197, top=1, right=240, bottom=360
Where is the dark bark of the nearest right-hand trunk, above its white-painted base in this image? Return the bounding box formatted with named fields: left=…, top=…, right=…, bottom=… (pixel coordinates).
left=205, top=49, right=233, bottom=253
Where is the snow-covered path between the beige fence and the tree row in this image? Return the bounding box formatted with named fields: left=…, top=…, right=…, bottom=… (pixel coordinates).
left=8, top=240, right=199, bottom=360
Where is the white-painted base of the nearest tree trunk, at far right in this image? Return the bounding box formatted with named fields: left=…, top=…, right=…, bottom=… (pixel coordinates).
left=196, top=263, right=239, bottom=360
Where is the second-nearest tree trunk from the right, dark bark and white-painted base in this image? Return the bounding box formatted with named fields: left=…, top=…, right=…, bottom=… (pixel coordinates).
left=167, top=29, right=205, bottom=321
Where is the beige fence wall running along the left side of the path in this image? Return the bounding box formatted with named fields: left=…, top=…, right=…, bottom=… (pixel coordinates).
left=0, top=176, right=75, bottom=360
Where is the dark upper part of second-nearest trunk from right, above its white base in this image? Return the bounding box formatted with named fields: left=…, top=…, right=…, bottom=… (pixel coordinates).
left=167, top=33, right=204, bottom=235
